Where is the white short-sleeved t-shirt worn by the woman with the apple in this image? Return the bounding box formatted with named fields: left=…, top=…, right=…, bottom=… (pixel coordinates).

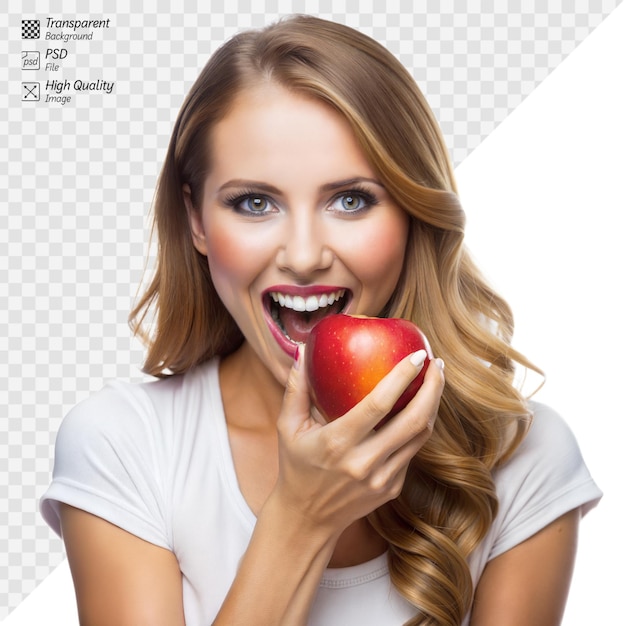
left=41, top=360, right=602, bottom=626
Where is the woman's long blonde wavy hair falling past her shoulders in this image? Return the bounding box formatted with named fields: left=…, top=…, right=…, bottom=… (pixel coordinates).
left=130, top=16, right=539, bottom=626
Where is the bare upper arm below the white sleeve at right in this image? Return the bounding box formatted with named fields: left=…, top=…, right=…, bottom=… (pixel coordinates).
left=470, top=509, right=580, bottom=626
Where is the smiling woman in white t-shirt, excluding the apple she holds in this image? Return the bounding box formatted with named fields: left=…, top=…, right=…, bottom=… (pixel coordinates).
left=42, top=17, right=601, bottom=626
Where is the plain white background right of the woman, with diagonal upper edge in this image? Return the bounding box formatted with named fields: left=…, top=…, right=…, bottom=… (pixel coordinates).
left=458, top=5, right=626, bottom=626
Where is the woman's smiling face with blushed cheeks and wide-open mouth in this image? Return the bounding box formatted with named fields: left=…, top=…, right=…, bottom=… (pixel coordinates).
left=185, top=84, right=408, bottom=384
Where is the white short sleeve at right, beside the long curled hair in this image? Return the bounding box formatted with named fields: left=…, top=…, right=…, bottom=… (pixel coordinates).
left=488, top=403, right=602, bottom=559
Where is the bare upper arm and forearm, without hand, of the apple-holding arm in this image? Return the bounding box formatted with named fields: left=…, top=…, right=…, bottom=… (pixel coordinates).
left=60, top=502, right=332, bottom=626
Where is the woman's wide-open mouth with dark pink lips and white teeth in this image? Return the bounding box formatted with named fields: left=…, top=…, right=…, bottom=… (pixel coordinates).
left=264, top=288, right=351, bottom=344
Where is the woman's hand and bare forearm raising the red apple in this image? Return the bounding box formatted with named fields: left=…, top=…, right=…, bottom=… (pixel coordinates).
left=214, top=349, right=444, bottom=626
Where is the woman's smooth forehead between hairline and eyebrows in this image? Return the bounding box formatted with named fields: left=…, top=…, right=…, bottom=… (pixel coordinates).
left=209, top=83, right=374, bottom=185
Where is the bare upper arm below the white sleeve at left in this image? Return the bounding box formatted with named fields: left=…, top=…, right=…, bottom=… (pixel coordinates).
left=60, top=504, right=185, bottom=626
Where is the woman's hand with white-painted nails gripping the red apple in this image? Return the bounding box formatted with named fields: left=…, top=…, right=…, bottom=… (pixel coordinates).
left=270, top=348, right=444, bottom=535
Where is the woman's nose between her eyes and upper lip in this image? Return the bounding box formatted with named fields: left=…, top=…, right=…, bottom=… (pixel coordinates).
left=276, top=210, right=334, bottom=280
